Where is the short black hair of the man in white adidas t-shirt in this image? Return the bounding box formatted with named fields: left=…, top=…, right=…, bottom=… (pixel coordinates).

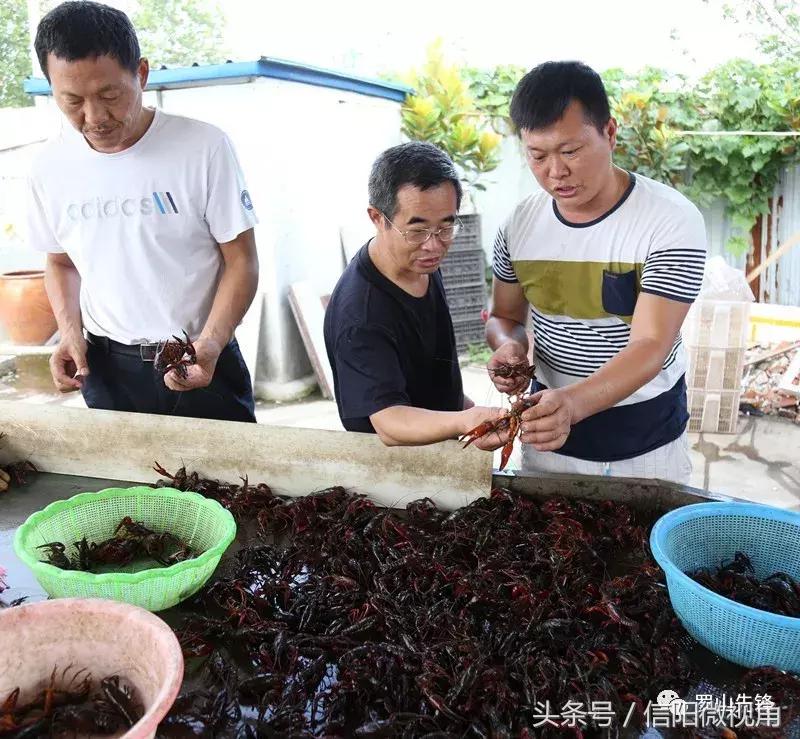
left=34, top=0, right=141, bottom=82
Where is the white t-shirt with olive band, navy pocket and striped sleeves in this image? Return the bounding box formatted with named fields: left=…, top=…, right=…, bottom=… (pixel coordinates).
left=494, top=174, right=706, bottom=462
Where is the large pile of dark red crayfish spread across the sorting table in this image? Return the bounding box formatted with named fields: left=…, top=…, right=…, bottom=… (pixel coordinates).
left=152, top=467, right=800, bottom=737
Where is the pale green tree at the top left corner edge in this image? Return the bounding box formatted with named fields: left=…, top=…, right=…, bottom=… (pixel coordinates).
left=0, top=0, right=32, bottom=108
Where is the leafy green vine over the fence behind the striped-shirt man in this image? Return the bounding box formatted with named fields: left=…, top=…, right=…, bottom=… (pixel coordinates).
left=603, top=58, right=800, bottom=253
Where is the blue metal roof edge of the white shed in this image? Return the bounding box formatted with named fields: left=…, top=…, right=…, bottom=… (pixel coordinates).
left=24, top=57, right=412, bottom=103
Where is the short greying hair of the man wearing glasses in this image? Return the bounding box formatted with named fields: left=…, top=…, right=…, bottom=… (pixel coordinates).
left=369, top=141, right=463, bottom=218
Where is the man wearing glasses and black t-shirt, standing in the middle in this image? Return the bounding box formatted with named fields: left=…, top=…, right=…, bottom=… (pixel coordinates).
left=325, top=141, right=501, bottom=448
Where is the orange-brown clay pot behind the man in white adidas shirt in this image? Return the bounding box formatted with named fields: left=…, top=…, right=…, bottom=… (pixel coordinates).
left=0, top=270, right=57, bottom=346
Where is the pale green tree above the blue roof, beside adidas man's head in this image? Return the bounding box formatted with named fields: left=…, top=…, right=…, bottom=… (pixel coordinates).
left=131, top=0, right=228, bottom=69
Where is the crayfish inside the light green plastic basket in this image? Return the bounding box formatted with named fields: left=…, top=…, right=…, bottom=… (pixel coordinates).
left=37, top=516, right=197, bottom=572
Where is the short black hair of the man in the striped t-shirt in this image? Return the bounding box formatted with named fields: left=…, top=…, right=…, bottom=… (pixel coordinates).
left=510, top=62, right=611, bottom=133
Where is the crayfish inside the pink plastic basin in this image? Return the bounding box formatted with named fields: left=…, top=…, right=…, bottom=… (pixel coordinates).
left=0, top=667, right=144, bottom=739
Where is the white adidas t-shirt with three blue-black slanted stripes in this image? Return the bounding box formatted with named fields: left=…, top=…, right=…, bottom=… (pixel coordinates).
left=28, top=110, right=258, bottom=344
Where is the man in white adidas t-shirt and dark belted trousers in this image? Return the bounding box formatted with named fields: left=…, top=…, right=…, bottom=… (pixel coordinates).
left=28, top=2, right=258, bottom=421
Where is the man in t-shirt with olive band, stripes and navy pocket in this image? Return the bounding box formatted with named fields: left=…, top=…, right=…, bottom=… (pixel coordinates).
left=486, top=62, right=706, bottom=482
